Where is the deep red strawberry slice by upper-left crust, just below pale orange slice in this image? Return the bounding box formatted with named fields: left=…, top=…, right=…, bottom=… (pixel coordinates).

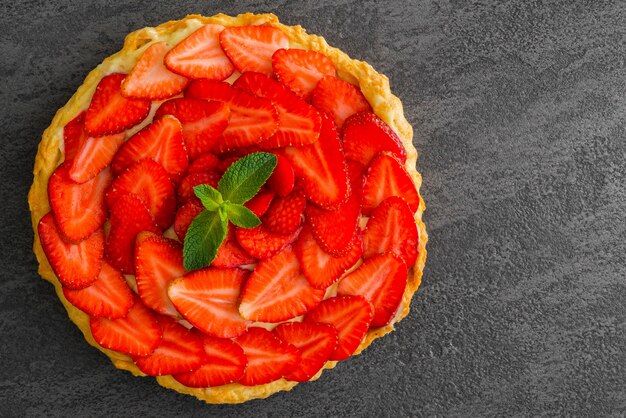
left=85, top=74, right=151, bottom=136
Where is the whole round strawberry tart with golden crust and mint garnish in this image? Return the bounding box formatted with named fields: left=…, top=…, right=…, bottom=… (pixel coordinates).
left=29, top=13, right=427, bottom=403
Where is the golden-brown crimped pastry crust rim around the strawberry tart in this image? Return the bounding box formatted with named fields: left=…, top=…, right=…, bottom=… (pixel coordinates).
left=28, top=13, right=428, bottom=403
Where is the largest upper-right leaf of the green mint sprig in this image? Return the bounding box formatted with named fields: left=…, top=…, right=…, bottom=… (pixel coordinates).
left=217, top=152, right=277, bottom=204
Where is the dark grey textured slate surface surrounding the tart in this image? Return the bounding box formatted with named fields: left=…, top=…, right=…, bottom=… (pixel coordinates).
left=0, top=0, right=626, bottom=417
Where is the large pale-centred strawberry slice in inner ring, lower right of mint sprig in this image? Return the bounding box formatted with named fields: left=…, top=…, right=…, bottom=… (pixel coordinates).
left=239, top=247, right=325, bottom=322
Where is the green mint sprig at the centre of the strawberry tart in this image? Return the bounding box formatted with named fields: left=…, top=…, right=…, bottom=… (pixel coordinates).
left=183, top=152, right=277, bottom=270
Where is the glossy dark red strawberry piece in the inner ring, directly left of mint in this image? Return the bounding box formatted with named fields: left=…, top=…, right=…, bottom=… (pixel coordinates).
left=106, top=193, right=159, bottom=274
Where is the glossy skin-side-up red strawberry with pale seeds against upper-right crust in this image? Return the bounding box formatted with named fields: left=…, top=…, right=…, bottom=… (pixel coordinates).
left=342, top=111, right=406, bottom=167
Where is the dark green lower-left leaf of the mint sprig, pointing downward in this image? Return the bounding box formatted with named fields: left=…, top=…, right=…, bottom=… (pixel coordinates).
left=183, top=210, right=228, bottom=271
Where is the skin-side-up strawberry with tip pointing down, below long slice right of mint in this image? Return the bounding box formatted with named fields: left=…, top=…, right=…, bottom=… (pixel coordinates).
left=306, top=185, right=361, bottom=256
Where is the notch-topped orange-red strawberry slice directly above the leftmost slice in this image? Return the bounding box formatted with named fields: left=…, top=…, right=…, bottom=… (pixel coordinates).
left=48, top=163, right=112, bottom=241
